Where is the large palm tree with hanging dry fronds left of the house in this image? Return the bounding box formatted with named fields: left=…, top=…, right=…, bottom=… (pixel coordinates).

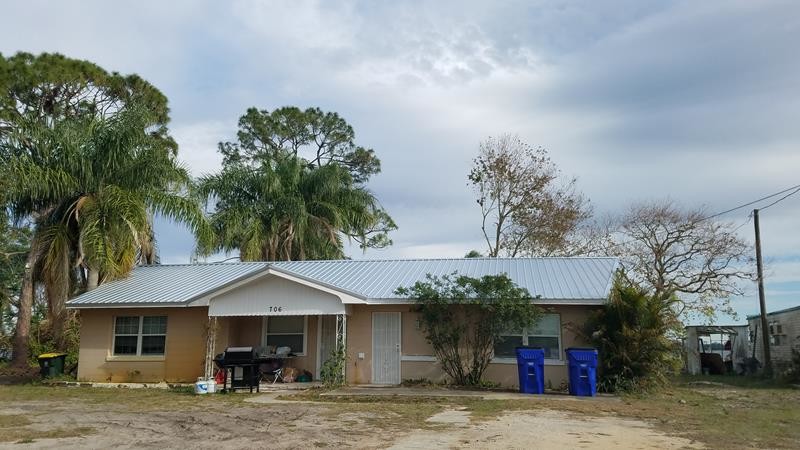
left=6, top=106, right=211, bottom=352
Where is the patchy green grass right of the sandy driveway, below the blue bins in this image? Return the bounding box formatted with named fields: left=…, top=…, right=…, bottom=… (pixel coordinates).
left=290, top=376, right=800, bottom=449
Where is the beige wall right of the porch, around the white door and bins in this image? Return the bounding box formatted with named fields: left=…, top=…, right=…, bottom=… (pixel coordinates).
left=347, top=305, right=597, bottom=387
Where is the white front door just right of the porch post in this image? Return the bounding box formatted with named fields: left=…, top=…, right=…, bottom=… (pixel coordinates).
left=372, top=312, right=400, bottom=384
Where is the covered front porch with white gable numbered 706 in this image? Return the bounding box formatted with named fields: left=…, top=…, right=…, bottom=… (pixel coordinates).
left=198, top=272, right=351, bottom=381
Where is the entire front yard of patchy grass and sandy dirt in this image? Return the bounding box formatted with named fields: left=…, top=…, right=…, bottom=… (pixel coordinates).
left=0, top=378, right=800, bottom=449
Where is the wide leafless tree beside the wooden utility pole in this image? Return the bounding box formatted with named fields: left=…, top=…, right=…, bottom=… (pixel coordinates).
left=609, top=201, right=753, bottom=317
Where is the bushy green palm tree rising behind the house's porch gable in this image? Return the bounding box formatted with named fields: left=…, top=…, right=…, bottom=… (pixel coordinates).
left=198, top=155, right=394, bottom=261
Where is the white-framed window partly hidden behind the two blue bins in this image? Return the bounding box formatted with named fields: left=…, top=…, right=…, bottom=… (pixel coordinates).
left=494, top=314, right=562, bottom=360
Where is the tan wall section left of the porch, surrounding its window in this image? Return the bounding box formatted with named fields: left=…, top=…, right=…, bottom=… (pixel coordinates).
left=78, top=307, right=208, bottom=382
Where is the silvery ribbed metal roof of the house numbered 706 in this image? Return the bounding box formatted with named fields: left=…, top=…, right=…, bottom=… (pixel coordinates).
left=68, top=258, right=617, bottom=307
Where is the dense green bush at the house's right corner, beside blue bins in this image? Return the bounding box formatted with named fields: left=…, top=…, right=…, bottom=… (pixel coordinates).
left=582, top=276, right=681, bottom=392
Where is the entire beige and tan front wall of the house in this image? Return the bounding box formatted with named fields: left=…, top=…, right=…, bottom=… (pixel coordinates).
left=78, top=298, right=592, bottom=387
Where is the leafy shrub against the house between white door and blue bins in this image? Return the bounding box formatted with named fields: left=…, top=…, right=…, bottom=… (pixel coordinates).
left=396, top=273, right=541, bottom=386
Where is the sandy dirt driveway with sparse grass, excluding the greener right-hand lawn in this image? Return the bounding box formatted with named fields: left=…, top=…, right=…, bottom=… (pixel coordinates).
left=0, top=386, right=699, bottom=449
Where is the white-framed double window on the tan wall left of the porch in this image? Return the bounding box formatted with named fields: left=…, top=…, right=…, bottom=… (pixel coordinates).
left=112, top=316, right=167, bottom=356
